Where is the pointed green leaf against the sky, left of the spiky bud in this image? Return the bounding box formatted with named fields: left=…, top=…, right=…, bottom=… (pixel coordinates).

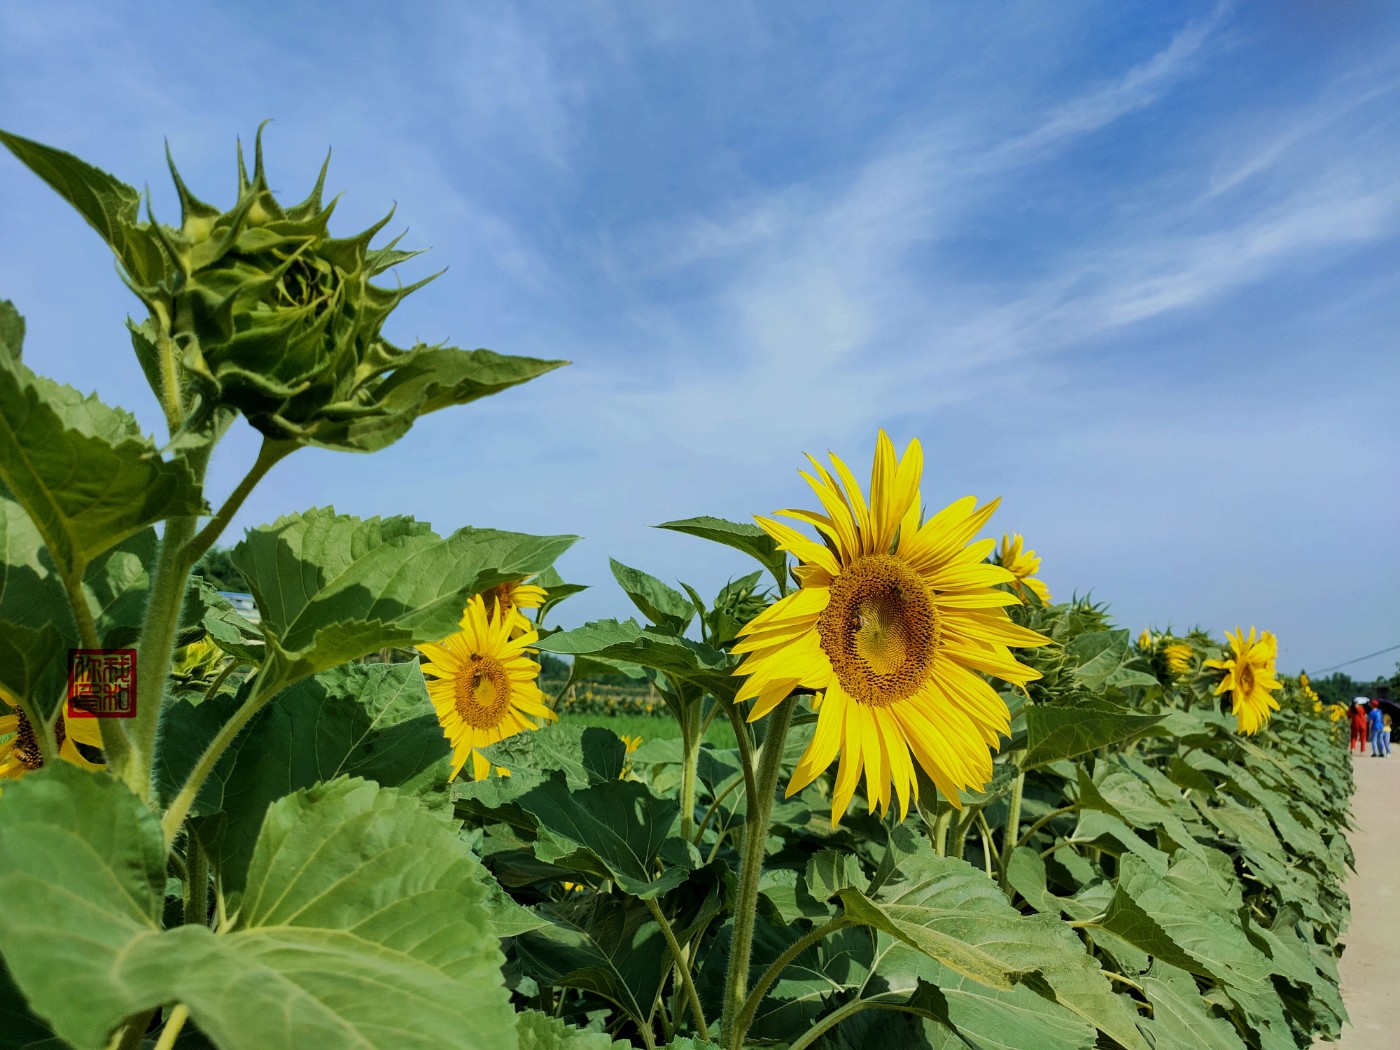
left=0, top=132, right=165, bottom=286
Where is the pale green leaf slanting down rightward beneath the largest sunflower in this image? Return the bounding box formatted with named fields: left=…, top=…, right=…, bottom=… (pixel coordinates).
left=840, top=851, right=1147, bottom=1050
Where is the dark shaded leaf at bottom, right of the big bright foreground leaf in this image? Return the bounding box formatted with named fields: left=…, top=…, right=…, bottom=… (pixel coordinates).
left=515, top=893, right=669, bottom=1025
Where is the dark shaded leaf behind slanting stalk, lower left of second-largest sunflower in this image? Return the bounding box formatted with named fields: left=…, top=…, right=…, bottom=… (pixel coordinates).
left=161, top=664, right=451, bottom=893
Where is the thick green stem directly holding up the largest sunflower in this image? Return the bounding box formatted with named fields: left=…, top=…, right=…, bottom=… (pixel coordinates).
left=722, top=696, right=797, bottom=1050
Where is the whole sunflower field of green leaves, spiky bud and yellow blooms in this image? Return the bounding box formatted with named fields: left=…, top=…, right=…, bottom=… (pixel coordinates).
left=0, top=133, right=1352, bottom=1050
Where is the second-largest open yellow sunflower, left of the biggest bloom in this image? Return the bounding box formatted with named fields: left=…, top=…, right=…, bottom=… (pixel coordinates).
left=419, top=595, right=557, bottom=780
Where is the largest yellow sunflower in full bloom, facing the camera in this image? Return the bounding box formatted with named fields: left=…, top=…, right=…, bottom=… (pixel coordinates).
left=734, top=431, right=1050, bottom=825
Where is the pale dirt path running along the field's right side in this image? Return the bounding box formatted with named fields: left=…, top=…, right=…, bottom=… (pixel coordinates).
left=1316, top=746, right=1400, bottom=1050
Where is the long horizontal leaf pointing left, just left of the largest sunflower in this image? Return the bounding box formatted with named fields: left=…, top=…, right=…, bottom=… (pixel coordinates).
left=539, top=620, right=738, bottom=701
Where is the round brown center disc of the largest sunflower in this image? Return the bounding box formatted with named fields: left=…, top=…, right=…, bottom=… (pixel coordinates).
left=816, top=554, right=938, bottom=707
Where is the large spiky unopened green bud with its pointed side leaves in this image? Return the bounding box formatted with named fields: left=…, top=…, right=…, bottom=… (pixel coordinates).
left=0, top=129, right=566, bottom=451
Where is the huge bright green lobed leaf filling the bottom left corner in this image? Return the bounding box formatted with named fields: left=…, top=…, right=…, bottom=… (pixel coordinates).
left=0, top=764, right=514, bottom=1050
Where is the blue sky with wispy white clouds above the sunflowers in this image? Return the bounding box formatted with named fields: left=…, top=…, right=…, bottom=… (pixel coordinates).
left=0, top=0, right=1400, bottom=678
